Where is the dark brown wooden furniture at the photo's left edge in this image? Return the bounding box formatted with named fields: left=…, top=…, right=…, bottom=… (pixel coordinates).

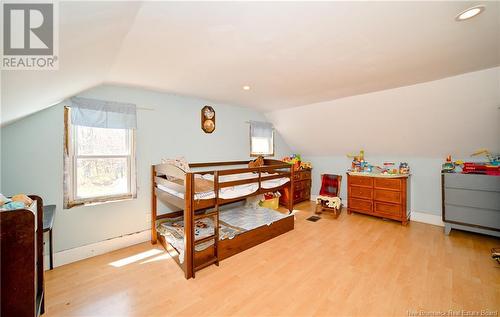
left=0, top=196, right=45, bottom=317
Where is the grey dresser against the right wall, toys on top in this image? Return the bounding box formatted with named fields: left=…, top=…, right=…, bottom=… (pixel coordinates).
left=441, top=173, right=500, bottom=237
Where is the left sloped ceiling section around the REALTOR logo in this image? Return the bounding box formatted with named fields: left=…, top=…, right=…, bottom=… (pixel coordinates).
left=1, top=2, right=140, bottom=124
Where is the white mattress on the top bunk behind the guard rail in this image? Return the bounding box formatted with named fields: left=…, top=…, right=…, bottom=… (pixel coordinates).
left=158, top=173, right=290, bottom=200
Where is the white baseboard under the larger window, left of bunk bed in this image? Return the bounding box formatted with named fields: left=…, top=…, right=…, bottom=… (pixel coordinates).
left=44, top=230, right=151, bottom=270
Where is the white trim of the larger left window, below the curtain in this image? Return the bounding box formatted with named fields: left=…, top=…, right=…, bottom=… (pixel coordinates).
left=67, top=119, right=137, bottom=206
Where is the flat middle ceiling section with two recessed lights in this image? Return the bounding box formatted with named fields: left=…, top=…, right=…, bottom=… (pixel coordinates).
left=107, top=1, right=500, bottom=112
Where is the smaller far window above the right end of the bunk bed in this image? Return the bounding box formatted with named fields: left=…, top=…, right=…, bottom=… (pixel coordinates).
left=250, top=121, right=274, bottom=156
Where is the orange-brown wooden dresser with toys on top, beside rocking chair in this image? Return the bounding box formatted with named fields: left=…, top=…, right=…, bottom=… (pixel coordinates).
left=347, top=173, right=410, bottom=225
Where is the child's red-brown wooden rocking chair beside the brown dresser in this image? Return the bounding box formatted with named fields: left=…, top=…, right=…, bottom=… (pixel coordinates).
left=316, top=174, right=342, bottom=219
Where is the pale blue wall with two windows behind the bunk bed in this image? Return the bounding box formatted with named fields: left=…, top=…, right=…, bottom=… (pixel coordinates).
left=1, top=86, right=289, bottom=251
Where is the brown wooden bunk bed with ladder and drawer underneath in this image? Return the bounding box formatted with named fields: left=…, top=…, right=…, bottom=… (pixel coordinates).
left=151, top=159, right=294, bottom=279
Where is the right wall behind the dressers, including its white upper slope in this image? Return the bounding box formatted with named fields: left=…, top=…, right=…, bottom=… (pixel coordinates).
left=266, top=67, right=500, bottom=215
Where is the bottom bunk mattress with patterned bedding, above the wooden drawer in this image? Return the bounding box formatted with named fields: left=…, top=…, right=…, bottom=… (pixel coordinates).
left=156, top=206, right=293, bottom=263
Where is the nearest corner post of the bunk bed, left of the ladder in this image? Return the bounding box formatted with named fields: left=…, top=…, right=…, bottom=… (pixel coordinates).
left=184, top=173, right=194, bottom=279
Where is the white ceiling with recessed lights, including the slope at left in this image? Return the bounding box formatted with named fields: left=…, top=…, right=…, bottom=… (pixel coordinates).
left=1, top=1, right=500, bottom=131
